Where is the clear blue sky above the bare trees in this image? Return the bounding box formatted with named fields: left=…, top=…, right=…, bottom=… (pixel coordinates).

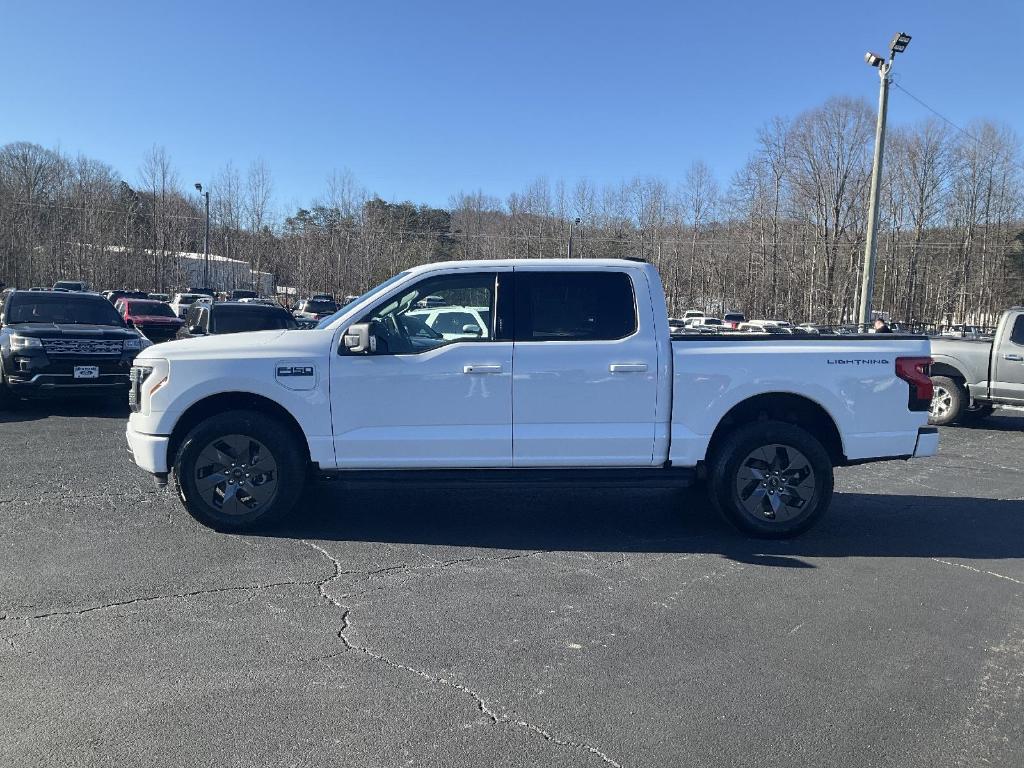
left=0, top=0, right=1024, bottom=211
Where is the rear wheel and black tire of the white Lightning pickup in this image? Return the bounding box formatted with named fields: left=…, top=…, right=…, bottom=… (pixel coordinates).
left=708, top=421, right=834, bottom=539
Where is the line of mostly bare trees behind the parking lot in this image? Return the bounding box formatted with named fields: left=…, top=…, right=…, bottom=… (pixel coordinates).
left=0, top=97, right=1024, bottom=325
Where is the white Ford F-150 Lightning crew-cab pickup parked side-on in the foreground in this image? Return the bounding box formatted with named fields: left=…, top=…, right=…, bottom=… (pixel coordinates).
left=127, top=259, right=939, bottom=537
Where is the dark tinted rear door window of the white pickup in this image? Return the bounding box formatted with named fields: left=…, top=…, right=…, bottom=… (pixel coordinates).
left=515, top=270, right=637, bottom=341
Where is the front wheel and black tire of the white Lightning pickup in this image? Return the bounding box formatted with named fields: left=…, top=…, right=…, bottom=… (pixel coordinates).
left=172, top=411, right=308, bottom=532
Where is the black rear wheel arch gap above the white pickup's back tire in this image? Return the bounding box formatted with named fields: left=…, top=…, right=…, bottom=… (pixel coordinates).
left=707, top=392, right=846, bottom=465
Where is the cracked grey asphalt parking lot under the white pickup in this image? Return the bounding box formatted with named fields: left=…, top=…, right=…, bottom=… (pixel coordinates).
left=0, top=402, right=1024, bottom=767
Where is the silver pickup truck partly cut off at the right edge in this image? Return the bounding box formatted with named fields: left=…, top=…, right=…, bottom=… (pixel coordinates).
left=929, top=306, right=1024, bottom=426
